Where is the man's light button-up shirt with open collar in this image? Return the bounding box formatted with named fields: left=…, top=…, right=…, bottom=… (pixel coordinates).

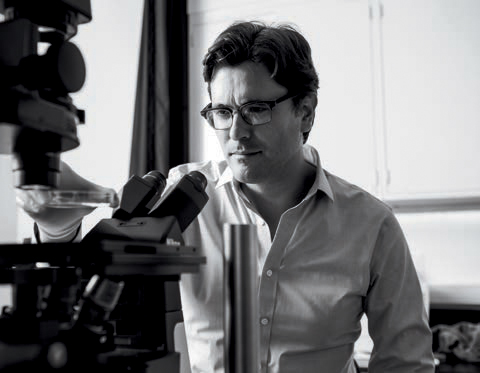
left=154, top=145, right=434, bottom=373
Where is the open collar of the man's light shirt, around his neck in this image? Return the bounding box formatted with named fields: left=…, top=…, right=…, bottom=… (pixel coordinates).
left=215, top=144, right=334, bottom=201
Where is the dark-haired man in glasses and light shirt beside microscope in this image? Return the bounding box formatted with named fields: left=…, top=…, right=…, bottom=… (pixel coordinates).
left=21, top=22, right=434, bottom=373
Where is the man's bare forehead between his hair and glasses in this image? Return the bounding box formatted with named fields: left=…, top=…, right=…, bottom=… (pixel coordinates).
left=210, top=61, right=287, bottom=105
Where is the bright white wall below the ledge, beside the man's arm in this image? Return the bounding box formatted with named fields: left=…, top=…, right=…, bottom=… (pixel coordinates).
left=397, top=210, right=480, bottom=304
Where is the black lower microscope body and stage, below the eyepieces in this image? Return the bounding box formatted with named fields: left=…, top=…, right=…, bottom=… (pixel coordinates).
left=0, top=179, right=208, bottom=373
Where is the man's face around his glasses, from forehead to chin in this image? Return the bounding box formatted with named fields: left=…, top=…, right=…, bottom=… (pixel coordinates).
left=210, top=61, right=311, bottom=184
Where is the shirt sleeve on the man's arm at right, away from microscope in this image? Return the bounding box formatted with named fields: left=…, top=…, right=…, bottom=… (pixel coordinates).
left=365, top=214, right=435, bottom=373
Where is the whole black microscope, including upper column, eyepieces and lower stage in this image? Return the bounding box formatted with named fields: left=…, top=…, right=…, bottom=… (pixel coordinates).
left=0, top=0, right=208, bottom=373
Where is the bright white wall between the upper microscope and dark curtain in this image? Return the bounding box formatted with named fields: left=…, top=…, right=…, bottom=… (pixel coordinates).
left=64, top=0, right=143, bottom=187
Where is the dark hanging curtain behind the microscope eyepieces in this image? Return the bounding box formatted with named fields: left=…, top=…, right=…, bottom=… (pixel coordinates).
left=130, top=0, right=188, bottom=176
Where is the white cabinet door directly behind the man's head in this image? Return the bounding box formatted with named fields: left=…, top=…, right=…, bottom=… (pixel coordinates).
left=189, top=0, right=376, bottom=191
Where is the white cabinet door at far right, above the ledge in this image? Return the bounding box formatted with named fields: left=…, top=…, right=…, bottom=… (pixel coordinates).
left=382, top=0, right=480, bottom=199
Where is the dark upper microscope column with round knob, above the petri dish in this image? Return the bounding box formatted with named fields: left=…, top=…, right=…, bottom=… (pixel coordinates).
left=0, top=0, right=92, bottom=190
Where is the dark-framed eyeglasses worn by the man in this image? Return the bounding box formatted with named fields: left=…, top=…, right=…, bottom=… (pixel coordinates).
left=200, top=93, right=296, bottom=130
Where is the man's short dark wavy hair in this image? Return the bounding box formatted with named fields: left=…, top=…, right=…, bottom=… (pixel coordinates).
left=203, top=22, right=318, bottom=142
